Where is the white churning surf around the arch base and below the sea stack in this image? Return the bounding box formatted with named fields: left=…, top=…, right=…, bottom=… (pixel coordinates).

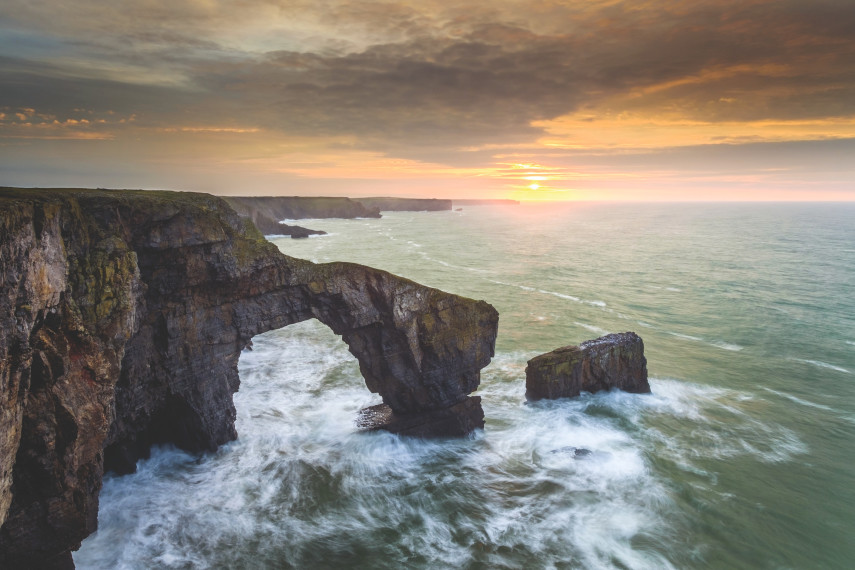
left=74, top=328, right=684, bottom=569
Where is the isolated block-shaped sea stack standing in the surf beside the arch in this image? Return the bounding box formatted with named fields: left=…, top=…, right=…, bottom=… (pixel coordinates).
left=525, top=332, right=650, bottom=400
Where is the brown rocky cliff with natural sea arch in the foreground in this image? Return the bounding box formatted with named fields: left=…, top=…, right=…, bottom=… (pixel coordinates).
left=0, top=189, right=498, bottom=568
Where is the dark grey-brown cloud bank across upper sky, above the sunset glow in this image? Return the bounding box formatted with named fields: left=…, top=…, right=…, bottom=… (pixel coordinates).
left=0, top=0, right=855, bottom=157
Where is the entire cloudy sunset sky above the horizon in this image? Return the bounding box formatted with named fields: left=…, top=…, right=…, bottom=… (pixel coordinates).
left=0, top=0, right=855, bottom=201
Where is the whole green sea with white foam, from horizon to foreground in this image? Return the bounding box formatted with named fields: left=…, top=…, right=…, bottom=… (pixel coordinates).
left=74, top=203, right=855, bottom=569
